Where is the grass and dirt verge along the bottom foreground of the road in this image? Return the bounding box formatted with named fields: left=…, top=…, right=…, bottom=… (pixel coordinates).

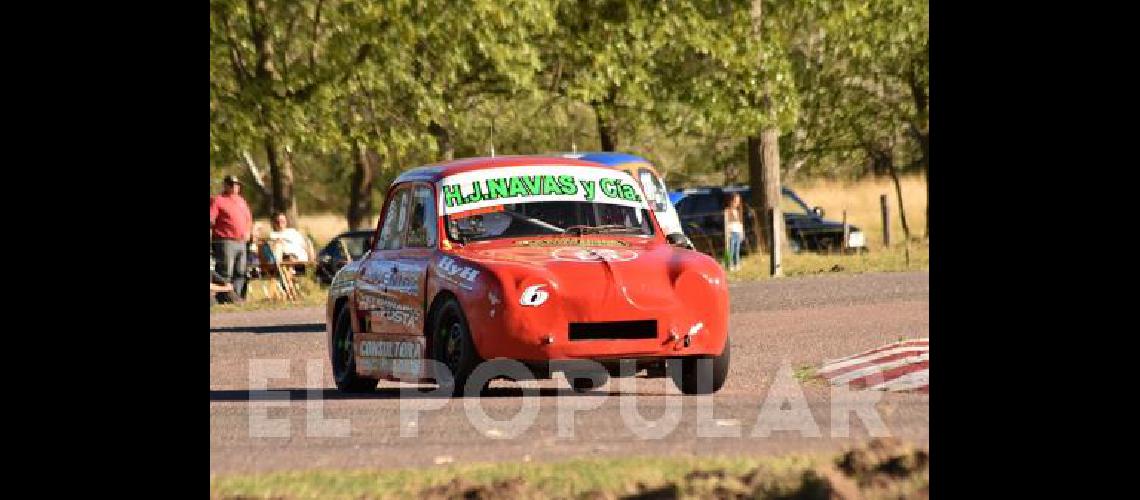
left=210, top=440, right=929, bottom=499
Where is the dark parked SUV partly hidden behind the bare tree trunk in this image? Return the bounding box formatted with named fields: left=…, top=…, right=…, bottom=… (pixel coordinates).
left=669, top=186, right=866, bottom=256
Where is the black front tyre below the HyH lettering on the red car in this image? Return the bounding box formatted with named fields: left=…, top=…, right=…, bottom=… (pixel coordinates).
left=430, top=297, right=482, bottom=395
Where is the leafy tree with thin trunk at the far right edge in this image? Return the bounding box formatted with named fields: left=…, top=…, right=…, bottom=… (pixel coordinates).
left=797, top=0, right=930, bottom=237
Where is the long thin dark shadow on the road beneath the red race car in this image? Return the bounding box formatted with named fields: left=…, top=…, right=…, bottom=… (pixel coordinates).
left=210, top=387, right=620, bottom=401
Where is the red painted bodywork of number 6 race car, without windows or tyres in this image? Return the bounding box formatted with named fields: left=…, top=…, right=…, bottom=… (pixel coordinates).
left=326, top=156, right=728, bottom=380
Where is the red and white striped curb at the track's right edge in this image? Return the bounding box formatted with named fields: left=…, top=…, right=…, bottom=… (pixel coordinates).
left=817, top=338, right=930, bottom=393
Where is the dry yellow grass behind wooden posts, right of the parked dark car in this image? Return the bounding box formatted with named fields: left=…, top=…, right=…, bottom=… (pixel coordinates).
left=789, top=175, right=927, bottom=251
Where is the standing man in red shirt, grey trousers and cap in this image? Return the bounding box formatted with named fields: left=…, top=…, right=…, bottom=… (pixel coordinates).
left=210, top=175, right=253, bottom=302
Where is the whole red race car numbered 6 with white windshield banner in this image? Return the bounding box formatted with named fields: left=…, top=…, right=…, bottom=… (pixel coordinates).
left=326, top=156, right=730, bottom=394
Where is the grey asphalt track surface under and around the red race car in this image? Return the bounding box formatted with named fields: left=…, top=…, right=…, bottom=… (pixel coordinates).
left=210, top=272, right=929, bottom=475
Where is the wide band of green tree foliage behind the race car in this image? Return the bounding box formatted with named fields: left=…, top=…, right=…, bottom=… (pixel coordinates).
left=210, top=0, right=929, bottom=212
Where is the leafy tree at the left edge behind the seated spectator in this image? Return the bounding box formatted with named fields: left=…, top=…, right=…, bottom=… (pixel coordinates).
left=210, top=0, right=372, bottom=222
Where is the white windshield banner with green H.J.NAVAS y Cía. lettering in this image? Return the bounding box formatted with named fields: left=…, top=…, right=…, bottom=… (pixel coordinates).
left=439, top=166, right=648, bottom=215
